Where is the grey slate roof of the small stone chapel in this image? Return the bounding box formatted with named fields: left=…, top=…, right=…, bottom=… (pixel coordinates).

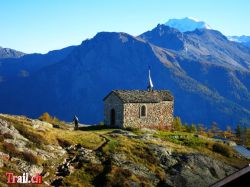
left=104, top=90, right=174, bottom=103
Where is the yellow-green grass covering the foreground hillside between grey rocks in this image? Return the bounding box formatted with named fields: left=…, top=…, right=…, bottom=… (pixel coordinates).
left=0, top=115, right=248, bottom=186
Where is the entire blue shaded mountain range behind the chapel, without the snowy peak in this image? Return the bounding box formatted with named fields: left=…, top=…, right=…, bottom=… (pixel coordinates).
left=0, top=17, right=250, bottom=127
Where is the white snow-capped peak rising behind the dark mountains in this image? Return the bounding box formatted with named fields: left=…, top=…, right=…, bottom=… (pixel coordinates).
left=165, top=17, right=211, bottom=32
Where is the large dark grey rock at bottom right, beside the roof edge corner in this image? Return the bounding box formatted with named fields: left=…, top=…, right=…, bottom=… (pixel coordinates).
left=165, top=154, right=236, bottom=187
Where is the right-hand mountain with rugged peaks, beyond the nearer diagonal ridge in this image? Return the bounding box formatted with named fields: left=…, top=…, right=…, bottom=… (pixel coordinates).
left=139, top=25, right=250, bottom=124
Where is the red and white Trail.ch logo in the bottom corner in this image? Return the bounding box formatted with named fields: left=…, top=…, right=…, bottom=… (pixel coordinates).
left=6, top=172, right=42, bottom=184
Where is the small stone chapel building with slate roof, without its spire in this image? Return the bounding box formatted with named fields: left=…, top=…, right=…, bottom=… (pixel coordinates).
left=104, top=90, right=174, bottom=129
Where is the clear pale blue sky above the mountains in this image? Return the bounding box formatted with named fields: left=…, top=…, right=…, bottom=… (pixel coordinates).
left=0, top=0, right=250, bottom=53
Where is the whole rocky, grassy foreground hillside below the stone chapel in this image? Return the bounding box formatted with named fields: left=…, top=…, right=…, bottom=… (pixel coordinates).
left=0, top=114, right=247, bottom=186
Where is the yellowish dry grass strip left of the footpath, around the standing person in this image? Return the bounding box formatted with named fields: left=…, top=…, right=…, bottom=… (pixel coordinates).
left=0, top=115, right=105, bottom=149
